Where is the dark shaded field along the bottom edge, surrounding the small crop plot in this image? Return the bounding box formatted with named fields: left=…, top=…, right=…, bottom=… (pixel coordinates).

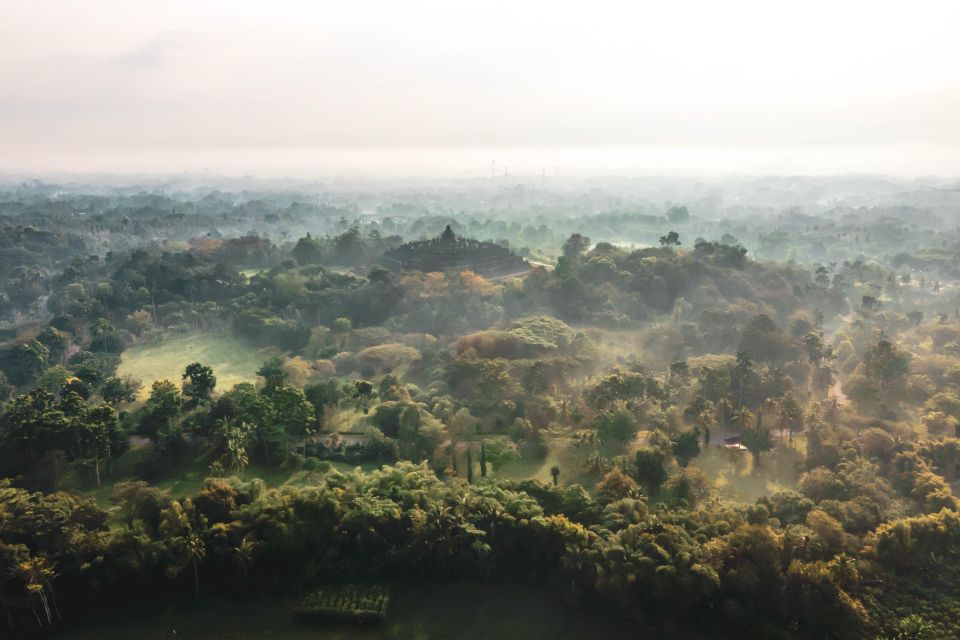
left=57, top=582, right=718, bottom=640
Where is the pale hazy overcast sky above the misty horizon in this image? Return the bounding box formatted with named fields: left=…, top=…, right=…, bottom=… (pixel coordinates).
left=0, top=0, right=960, bottom=177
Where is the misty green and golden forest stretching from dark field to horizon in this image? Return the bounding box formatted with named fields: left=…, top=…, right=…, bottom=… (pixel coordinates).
left=0, top=178, right=960, bottom=640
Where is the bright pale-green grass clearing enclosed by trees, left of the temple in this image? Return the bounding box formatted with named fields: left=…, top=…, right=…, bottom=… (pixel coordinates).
left=117, top=333, right=271, bottom=399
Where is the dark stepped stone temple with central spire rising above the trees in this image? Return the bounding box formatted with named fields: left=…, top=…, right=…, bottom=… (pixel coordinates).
left=380, top=225, right=530, bottom=278
